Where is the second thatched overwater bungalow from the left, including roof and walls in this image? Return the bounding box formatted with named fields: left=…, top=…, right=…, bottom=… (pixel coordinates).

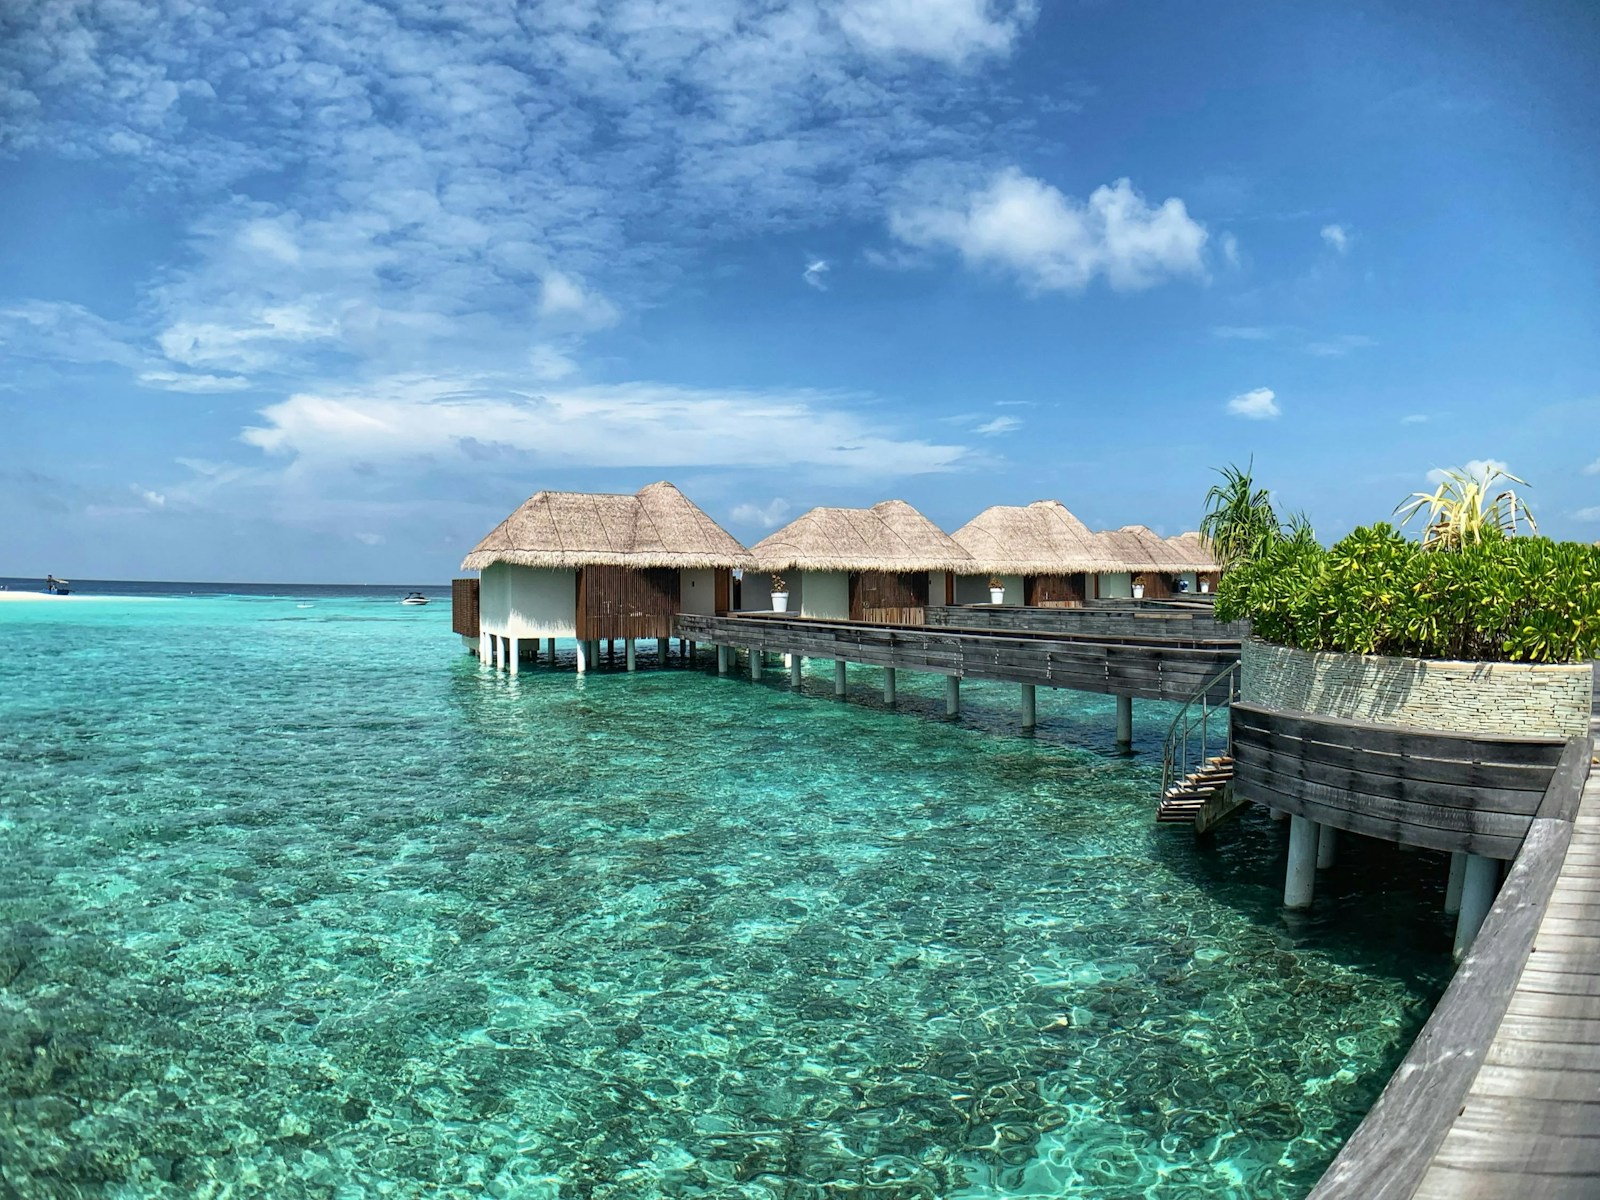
left=741, top=501, right=976, bottom=624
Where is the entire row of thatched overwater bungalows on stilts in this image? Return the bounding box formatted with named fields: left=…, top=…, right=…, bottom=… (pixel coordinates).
left=456, top=483, right=1218, bottom=670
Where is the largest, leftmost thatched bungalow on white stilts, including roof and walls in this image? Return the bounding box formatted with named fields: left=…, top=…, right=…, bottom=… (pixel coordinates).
left=461, top=483, right=754, bottom=670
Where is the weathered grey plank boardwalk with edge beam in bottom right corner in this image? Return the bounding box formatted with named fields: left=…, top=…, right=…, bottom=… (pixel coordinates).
left=1310, top=720, right=1600, bottom=1200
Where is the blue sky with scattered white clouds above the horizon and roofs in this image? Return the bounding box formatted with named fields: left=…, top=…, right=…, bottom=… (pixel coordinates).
left=0, top=0, right=1600, bottom=581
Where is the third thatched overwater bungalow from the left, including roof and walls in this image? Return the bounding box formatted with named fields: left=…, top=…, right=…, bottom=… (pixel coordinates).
left=950, top=499, right=1122, bottom=608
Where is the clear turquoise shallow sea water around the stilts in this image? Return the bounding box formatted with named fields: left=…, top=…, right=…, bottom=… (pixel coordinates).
left=0, top=592, right=1448, bottom=1200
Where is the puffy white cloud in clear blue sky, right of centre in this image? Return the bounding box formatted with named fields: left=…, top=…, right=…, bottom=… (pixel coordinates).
left=890, top=166, right=1206, bottom=291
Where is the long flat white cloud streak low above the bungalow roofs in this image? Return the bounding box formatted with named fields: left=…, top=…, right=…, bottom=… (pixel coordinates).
left=240, top=378, right=966, bottom=478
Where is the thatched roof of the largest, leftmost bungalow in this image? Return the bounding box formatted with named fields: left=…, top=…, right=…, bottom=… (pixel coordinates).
left=461, top=483, right=754, bottom=571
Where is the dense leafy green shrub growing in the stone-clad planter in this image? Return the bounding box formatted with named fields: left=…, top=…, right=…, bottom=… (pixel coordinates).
left=1216, top=525, right=1600, bottom=662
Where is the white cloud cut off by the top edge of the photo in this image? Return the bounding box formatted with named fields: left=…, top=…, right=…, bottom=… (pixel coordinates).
left=832, top=0, right=1037, bottom=66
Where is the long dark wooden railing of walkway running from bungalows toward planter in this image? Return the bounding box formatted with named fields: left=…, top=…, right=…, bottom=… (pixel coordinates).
left=677, top=613, right=1238, bottom=701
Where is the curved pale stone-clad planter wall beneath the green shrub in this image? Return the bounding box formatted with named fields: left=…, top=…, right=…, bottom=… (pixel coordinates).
left=1240, top=638, right=1595, bottom=738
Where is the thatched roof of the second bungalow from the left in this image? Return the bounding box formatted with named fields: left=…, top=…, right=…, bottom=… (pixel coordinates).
left=750, top=501, right=979, bottom=571
